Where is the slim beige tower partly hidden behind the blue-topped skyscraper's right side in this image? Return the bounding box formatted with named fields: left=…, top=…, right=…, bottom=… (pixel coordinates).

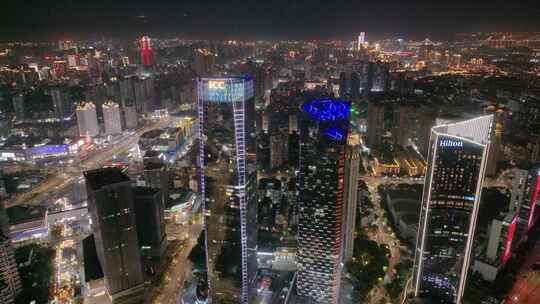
left=342, top=134, right=361, bottom=263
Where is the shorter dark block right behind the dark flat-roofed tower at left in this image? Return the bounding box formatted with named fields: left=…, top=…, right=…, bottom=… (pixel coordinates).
left=133, top=187, right=167, bottom=257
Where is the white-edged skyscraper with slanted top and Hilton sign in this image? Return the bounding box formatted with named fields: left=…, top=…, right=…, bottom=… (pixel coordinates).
left=413, top=115, right=493, bottom=303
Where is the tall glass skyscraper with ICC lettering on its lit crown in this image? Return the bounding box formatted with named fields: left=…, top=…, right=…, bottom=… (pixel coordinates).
left=197, top=77, right=257, bottom=304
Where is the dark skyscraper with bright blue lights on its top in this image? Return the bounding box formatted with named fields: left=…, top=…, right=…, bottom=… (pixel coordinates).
left=297, top=99, right=350, bottom=303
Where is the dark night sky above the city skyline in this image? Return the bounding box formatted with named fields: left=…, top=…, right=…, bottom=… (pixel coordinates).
left=0, top=0, right=540, bottom=40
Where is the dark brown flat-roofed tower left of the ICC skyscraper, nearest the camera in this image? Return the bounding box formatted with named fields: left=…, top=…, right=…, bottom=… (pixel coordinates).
left=84, top=168, right=144, bottom=303
